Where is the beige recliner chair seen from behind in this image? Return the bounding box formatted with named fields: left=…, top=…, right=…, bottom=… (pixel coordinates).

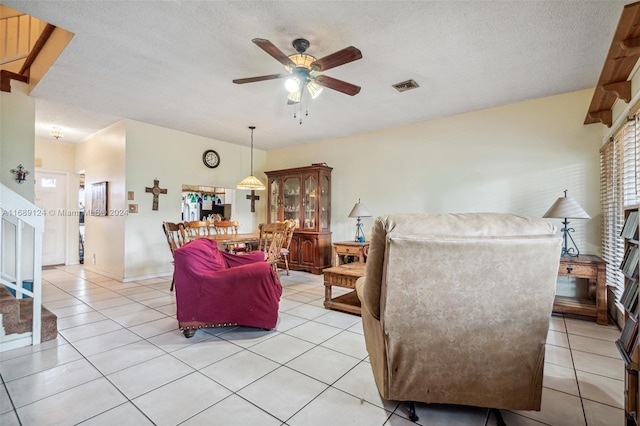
left=356, top=213, right=561, bottom=423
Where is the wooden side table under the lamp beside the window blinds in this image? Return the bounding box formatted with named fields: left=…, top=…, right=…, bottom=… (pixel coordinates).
left=553, top=254, right=609, bottom=325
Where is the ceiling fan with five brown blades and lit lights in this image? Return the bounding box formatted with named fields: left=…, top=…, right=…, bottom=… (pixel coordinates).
left=233, top=38, right=362, bottom=104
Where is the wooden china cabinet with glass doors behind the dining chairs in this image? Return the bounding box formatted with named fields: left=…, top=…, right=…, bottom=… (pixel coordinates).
left=265, top=165, right=332, bottom=274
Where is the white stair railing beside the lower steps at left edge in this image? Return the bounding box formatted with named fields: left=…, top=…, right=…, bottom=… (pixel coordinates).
left=0, top=184, right=44, bottom=350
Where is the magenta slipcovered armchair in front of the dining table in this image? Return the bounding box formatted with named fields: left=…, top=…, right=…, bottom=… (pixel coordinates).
left=173, top=238, right=282, bottom=338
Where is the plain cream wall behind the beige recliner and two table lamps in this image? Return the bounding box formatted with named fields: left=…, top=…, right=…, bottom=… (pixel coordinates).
left=267, top=90, right=602, bottom=254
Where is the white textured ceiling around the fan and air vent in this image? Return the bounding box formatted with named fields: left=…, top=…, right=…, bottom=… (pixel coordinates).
left=4, top=0, right=627, bottom=149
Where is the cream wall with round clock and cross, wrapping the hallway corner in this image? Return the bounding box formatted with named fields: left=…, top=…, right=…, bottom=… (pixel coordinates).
left=76, top=120, right=266, bottom=281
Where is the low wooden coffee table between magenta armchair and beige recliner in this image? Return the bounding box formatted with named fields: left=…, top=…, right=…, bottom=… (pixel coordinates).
left=322, top=263, right=366, bottom=315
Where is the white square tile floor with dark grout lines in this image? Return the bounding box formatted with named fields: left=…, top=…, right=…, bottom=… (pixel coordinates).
left=0, top=266, right=624, bottom=426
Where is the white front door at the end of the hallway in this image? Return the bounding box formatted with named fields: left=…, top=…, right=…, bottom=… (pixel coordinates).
left=35, top=171, right=67, bottom=265
